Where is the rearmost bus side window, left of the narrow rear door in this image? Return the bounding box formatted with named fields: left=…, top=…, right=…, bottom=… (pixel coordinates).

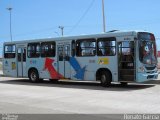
left=4, top=45, right=16, bottom=58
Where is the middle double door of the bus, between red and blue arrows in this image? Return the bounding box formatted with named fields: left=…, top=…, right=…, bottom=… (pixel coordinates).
left=58, top=44, right=71, bottom=79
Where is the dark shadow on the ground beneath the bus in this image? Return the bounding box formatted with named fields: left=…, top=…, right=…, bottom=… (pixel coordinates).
left=0, top=79, right=155, bottom=91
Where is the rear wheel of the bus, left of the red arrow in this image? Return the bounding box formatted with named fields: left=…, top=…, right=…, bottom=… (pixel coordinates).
left=29, top=69, right=40, bottom=83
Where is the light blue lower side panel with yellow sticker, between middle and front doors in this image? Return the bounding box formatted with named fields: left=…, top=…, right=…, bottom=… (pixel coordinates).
left=71, top=56, right=118, bottom=82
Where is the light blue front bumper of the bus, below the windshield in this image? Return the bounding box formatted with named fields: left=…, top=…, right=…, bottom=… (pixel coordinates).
left=137, top=72, right=158, bottom=82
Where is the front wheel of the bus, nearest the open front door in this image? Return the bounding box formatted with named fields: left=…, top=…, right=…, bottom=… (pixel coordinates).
left=100, top=71, right=111, bottom=87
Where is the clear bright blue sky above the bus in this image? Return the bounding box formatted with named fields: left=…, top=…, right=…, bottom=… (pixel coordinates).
left=0, top=0, right=160, bottom=56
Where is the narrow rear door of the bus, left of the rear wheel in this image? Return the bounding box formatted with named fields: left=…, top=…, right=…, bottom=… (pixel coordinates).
left=17, top=48, right=26, bottom=77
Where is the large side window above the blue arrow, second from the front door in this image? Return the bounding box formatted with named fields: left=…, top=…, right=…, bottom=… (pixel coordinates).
left=76, top=39, right=96, bottom=56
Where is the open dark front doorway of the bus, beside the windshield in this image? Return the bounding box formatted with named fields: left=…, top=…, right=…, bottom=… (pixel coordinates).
left=118, top=41, right=135, bottom=82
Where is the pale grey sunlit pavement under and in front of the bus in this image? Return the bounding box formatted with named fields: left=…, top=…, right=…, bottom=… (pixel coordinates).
left=0, top=77, right=160, bottom=114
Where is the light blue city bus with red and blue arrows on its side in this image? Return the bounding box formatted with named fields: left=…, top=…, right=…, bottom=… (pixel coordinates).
left=3, top=31, right=158, bottom=86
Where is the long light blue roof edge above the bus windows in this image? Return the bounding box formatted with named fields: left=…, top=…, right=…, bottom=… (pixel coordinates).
left=4, top=30, right=150, bottom=44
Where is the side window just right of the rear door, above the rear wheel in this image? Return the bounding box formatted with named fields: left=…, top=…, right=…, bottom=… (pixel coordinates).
left=28, top=43, right=40, bottom=58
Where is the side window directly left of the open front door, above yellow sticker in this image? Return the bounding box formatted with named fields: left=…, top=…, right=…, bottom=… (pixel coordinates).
left=97, top=38, right=116, bottom=56
